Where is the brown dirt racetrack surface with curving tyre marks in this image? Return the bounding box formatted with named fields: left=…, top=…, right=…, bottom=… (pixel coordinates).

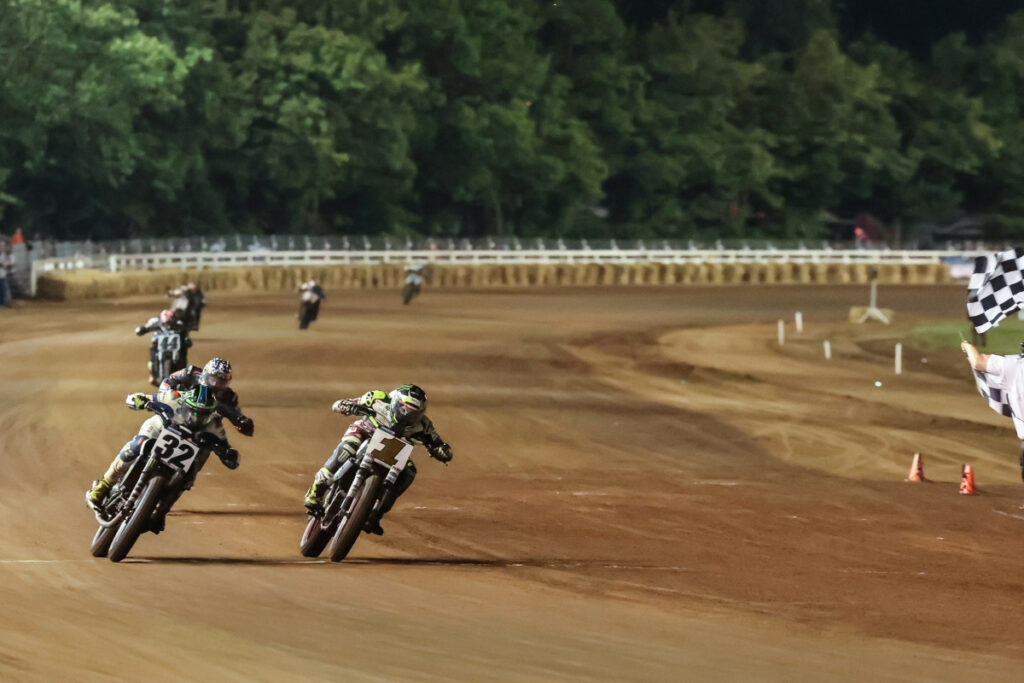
left=0, top=287, right=1024, bottom=681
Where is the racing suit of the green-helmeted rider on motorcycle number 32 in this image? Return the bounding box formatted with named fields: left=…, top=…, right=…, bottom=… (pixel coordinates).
left=86, top=393, right=239, bottom=520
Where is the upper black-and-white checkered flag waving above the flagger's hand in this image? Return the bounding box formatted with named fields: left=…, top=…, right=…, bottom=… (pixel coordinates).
left=967, top=249, right=1024, bottom=334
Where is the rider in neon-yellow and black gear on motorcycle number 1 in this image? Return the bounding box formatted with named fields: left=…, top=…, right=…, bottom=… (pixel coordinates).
left=305, top=384, right=452, bottom=535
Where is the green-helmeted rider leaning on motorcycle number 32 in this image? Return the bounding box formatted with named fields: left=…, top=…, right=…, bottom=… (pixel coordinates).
left=86, top=385, right=239, bottom=532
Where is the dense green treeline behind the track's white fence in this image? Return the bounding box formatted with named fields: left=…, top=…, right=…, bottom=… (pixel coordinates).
left=0, top=0, right=1024, bottom=239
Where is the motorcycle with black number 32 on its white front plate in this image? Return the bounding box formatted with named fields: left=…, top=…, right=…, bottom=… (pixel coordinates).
left=90, top=401, right=238, bottom=562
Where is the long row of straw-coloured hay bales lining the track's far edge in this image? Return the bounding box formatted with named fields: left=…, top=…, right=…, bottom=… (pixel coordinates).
left=37, top=263, right=953, bottom=301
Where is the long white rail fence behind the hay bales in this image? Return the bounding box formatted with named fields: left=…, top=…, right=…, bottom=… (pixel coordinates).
left=32, top=249, right=978, bottom=295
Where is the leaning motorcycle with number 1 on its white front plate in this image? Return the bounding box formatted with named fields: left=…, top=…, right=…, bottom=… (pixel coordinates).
left=300, top=417, right=413, bottom=562
